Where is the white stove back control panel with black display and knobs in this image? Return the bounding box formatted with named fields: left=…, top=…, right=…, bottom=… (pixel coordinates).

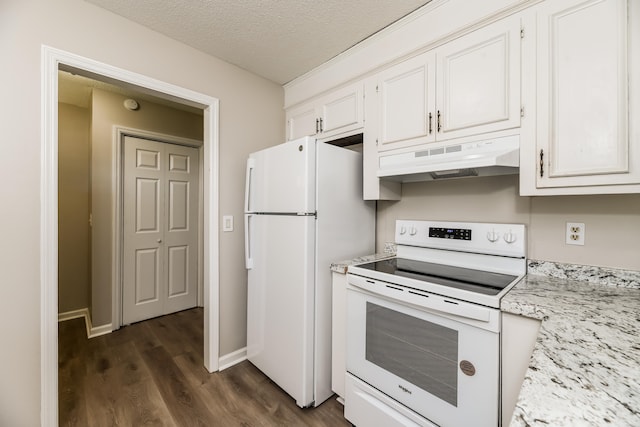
left=395, top=220, right=526, bottom=258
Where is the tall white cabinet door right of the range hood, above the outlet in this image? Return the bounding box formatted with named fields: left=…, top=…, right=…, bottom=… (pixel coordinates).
left=536, top=0, right=640, bottom=188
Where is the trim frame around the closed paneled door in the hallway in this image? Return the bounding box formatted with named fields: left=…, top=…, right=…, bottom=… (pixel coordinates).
left=111, top=129, right=204, bottom=331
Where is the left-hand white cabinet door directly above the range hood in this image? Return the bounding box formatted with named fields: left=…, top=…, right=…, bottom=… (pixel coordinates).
left=377, top=52, right=435, bottom=151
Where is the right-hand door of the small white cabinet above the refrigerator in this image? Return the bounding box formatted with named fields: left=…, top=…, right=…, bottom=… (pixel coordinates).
left=319, top=83, right=364, bottom=138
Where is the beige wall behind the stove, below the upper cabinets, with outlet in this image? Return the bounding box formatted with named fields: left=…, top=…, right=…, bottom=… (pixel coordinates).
left=377, top=175, right=640, bottom=270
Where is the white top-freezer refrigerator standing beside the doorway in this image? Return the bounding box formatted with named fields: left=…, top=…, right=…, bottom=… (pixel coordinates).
left=244, top=137, right=375, bottom=407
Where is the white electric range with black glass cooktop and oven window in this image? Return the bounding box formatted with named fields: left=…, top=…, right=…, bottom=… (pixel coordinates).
left=345, top=220, right=526, bottom=427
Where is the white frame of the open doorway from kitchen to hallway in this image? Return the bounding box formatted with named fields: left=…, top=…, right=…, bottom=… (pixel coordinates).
left=39, top=45, right=220, bottom=426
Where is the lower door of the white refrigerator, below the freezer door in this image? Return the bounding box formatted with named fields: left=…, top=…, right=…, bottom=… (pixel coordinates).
left=247, top=215, right=315, bottom=407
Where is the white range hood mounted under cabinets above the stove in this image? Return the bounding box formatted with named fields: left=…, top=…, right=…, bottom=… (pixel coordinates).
left=377, top=135, right=520, bottom=182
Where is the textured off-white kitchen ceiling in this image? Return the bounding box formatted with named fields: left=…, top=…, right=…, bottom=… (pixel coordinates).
left=86, top=0, right=430, bottom=84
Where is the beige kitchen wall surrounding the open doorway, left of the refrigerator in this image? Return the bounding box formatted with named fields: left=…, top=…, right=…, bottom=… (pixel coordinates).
left=0, top=0, right=284, bottom=426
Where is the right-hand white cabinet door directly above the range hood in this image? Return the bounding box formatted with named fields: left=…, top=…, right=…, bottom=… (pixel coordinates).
left=436, top=17, right=520, bottom=140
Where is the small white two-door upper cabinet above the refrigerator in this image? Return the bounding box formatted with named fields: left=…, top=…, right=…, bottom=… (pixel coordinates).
left=287, top=83, right=364, bottom=140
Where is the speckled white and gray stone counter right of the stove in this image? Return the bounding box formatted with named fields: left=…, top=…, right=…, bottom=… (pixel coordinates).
left=501, top=261, right=640, bottom=427
